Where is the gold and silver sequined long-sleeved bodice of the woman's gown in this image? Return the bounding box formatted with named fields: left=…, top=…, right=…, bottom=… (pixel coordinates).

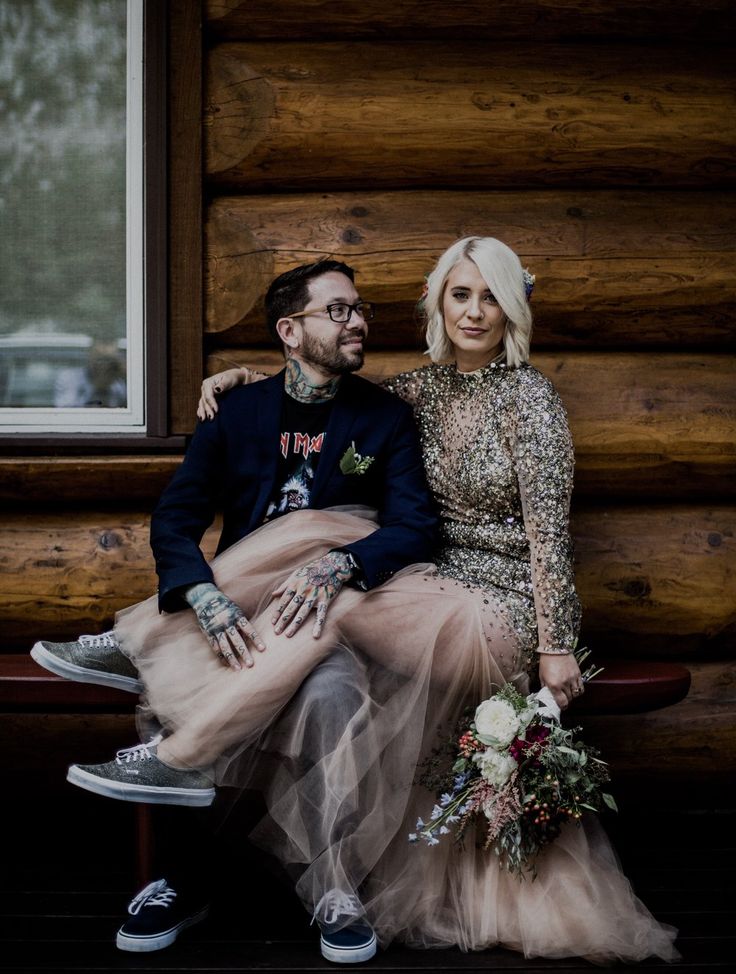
left=383, top=362, right=580, bottom=668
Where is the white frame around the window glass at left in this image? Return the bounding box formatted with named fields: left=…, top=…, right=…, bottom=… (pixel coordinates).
left=0, top=0, right=146, bottom=435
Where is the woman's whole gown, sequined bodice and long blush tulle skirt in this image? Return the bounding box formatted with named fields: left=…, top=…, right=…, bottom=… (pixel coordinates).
left=117, top=363, right=677, bottom=965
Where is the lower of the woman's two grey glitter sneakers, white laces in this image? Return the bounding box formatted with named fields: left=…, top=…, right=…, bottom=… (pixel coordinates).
left=66, top=734, right=215, bottom=806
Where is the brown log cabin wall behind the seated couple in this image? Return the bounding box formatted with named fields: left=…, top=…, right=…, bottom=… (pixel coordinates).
left=0, top=0, right=736, bottom=800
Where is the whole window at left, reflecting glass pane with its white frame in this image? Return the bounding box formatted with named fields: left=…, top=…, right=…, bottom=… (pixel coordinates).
left=0, top=0, right=143, bottom=428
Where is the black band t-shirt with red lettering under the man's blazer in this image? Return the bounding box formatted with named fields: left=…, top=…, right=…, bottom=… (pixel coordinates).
left=266, top=393, right=333, bottom=521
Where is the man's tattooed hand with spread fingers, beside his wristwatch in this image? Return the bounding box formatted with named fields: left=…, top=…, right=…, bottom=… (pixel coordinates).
left=271, top=551, right=353, bottom=639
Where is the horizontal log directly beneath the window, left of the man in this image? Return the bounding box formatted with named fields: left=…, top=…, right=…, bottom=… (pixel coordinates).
left=0, top=456, right=182, bottom=505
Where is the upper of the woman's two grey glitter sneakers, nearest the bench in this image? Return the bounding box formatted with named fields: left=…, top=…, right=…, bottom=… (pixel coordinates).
left=31, top=632, right=143, bottom=693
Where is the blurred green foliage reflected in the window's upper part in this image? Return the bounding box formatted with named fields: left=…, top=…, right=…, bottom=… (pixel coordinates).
left=0, top=0, right=126, bottom=340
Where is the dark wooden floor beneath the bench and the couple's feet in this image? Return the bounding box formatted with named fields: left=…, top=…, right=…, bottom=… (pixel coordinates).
left=0, top=793, right=736, bottom=974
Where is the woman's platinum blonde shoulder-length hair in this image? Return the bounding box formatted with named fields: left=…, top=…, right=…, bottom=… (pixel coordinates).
left=423, top=237, right=532, bottom=366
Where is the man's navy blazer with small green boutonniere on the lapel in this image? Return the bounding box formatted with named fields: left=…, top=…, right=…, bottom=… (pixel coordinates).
left=151, top=371, right=437, bottom=611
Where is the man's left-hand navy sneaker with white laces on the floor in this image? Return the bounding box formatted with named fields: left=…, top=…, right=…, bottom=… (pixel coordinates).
left=115, top=879, right=209, bottom=952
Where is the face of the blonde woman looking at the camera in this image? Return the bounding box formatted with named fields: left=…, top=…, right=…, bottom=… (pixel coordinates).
left=442, top=257, right=506, bottom=372
